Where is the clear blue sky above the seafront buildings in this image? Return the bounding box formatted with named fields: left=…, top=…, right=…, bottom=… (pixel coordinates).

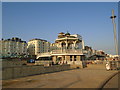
left=2, top=2, right=118, bottom=54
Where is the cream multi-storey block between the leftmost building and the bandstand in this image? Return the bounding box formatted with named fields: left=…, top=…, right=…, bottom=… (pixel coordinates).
left=27, top=38, right=50, bottom=55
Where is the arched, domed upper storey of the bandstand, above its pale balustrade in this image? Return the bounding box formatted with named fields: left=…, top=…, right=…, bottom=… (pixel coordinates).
left=51, top=32, right=84, bottom=50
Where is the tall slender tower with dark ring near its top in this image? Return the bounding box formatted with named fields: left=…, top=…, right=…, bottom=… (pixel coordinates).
left=110, top=10, right=118, bottom=55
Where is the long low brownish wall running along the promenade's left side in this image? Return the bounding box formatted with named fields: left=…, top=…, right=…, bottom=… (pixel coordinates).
left=2, top=64, right=71, bottom=80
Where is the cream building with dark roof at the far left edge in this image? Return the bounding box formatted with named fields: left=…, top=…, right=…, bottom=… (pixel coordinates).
left=0, top=37, right=27, bottom=56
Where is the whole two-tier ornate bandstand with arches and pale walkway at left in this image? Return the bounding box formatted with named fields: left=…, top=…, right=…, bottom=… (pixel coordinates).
left=37, top=32, right=85, bottom=67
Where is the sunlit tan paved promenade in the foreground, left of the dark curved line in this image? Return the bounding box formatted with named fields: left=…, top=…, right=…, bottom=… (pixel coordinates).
left=3, top=64, right=118, bottom=88
